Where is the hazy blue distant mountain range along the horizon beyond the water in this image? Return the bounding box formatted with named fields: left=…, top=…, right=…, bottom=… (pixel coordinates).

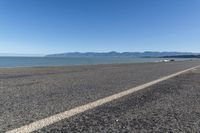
left=45, top=51, right=198, bottom=57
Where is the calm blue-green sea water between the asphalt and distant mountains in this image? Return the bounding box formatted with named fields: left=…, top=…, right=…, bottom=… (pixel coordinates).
left=0, top=57, right=189, bottom=67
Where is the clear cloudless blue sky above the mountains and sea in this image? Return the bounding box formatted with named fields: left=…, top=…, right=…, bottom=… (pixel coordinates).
left=0, top=0, right=200, bottom=54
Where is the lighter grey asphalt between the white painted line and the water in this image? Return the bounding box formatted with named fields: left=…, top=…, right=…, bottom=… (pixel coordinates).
left=0, top=61, right=200, bottom=132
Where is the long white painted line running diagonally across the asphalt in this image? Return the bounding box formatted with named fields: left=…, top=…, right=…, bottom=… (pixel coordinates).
left=6, top=66, right=200, bottom=133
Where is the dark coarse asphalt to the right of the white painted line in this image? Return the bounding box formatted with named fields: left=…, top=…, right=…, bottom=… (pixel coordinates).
left=35, top=65, right=200, bottom=133
